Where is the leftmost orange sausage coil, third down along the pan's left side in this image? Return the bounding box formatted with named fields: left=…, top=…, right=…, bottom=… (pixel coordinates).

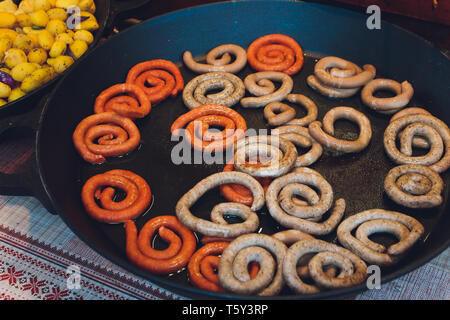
left=72, top=112, right=141, bottom=163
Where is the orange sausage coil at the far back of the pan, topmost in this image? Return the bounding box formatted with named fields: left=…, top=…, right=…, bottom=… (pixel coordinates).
left=247, top=34, right=303, bottom=75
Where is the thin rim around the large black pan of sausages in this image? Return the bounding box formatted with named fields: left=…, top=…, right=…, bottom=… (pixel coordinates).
left=35, top=0, right=450, bottom=300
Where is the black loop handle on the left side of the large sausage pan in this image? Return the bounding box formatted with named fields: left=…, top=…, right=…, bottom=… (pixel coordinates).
left=0, top=96, right=56, bottom=214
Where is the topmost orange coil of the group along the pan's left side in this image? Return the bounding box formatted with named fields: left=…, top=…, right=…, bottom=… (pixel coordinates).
left=126, top=59, right=184, bottom=104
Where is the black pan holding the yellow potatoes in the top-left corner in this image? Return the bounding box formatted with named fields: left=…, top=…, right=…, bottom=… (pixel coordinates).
left=0, top=0, right=148, bottom=117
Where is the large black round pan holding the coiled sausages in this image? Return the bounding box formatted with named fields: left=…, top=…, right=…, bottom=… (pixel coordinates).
left=2, top=1, right=450, bottom=299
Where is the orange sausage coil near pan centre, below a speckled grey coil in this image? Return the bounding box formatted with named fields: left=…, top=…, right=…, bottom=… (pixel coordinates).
left=170, top=104, right=247, bottom=152
